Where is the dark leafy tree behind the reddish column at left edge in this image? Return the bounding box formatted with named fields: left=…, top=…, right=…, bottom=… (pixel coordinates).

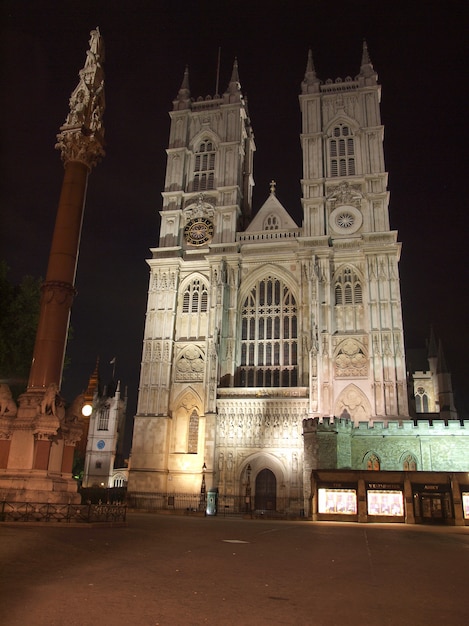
left=0, top=261, right=42, bottom=396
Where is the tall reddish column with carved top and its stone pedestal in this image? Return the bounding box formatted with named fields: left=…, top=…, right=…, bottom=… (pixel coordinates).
left=0, top=29, right=105, bottom=502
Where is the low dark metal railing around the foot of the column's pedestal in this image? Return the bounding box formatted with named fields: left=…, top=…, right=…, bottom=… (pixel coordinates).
left=0, top=500, right=127, bottom=524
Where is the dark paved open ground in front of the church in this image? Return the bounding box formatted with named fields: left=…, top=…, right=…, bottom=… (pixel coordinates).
left=0, top=512, right=469, bottom=626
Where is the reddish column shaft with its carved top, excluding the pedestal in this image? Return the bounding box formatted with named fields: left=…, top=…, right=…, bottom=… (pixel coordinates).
left=28, top=30, right=104, bottom=389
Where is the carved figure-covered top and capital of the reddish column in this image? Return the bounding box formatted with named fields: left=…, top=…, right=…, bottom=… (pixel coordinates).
left=55, top=28, right=105, bottom=169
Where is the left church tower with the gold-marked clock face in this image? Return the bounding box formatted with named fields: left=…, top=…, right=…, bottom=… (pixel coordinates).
left=130, top=60, right=255, bottom=493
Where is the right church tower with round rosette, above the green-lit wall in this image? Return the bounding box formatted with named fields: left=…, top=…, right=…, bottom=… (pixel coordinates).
left=300, top=43, right=408, bottom=423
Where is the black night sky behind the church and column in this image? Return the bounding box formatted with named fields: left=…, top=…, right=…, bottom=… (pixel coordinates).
left=0, top=0, right=469, bottom=428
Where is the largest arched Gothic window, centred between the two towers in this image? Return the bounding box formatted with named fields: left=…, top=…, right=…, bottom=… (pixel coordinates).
left=237, top=276, right=298, bottom=387
